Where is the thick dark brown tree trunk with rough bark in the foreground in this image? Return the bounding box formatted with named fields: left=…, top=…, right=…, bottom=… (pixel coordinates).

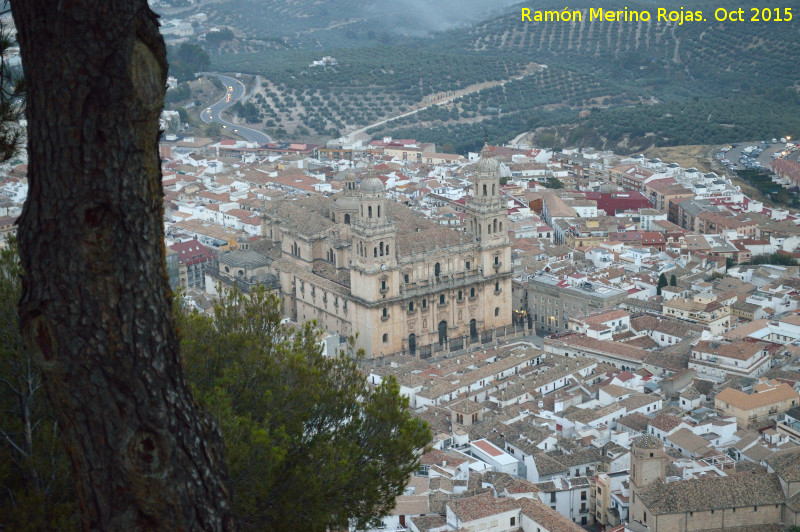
left=12, top=0, right=235, bottom=531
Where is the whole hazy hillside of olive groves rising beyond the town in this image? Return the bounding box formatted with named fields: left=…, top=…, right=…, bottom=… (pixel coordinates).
left=195, top=0, right=800, bottom=152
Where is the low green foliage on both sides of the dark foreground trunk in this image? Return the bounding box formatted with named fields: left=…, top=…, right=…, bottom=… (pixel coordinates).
left=0, top=239, right=431, bottom=531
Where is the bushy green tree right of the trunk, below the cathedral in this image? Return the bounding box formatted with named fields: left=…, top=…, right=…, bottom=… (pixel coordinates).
left=179, top=288, right=431, bottom=531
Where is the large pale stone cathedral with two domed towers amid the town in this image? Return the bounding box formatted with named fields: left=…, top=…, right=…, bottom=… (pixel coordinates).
left=211, top=147, right=512, bottom=358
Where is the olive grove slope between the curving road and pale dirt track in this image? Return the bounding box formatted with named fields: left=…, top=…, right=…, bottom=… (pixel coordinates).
left=209, top=48, right=525, bottom=136
